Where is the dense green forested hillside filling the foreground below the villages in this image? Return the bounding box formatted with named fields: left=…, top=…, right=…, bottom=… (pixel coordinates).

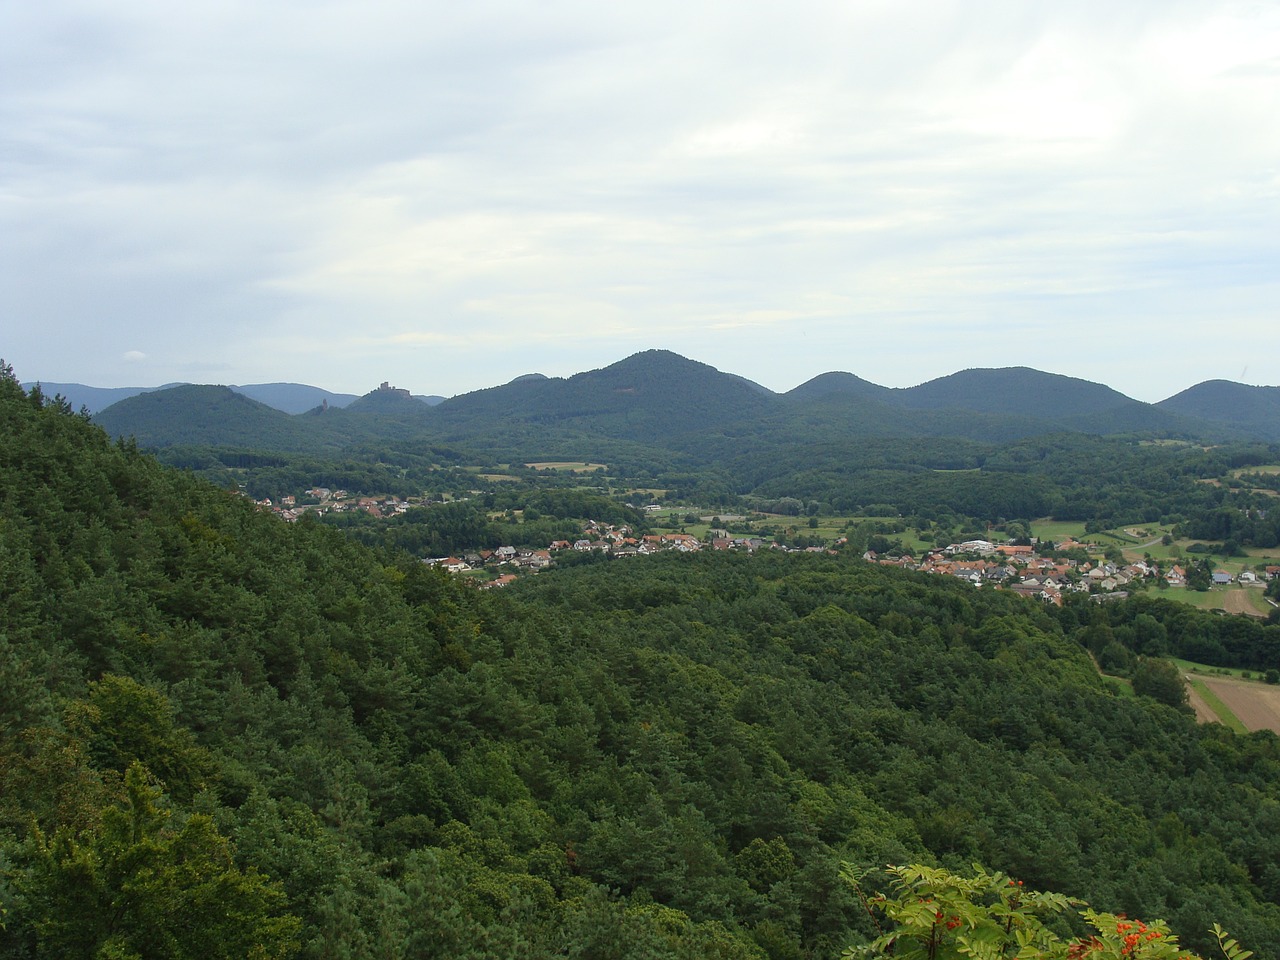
left=0, top=371, right=1280, bottom=960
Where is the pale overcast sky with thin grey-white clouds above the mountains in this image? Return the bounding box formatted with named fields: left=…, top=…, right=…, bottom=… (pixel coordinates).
left=0, top=0, right=1280, bottom=402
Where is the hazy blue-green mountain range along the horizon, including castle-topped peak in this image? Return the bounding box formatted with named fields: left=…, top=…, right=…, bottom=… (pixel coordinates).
left=44, top=349, right=1280, bottom=453
